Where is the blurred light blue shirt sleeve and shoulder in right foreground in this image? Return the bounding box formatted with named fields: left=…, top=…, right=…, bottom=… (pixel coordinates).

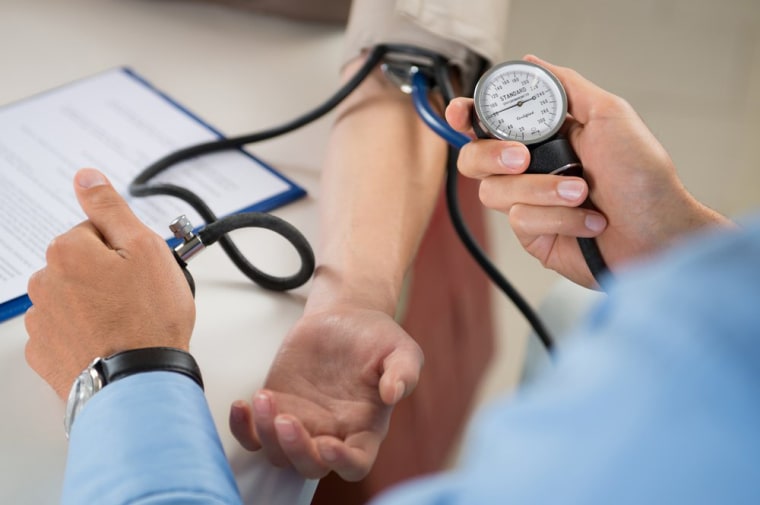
left=376, top=216, right=760, bottom=505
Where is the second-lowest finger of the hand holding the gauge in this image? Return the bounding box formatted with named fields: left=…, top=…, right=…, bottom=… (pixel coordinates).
left=478, top=174, right=588, bottom=214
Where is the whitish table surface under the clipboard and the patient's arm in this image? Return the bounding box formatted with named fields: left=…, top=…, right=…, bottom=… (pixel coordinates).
left=0, top=0, right=342, bottom=505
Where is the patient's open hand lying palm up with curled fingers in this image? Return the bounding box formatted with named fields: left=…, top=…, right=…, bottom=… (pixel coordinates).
left=230, top=306, right=423, bottom=481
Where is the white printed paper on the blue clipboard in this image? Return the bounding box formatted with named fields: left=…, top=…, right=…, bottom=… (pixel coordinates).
left=0, top=69, right=297, bottom=303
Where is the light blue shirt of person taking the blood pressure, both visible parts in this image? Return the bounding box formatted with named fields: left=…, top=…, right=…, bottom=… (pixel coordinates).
left=63, top=215, right=760, bottom=505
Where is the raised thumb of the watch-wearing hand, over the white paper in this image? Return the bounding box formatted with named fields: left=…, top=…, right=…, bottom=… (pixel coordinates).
left=74, top=168, right=144, bottom=249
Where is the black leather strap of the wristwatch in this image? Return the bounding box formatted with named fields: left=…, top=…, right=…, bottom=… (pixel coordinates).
left=100, top=347, right=203, bottom=389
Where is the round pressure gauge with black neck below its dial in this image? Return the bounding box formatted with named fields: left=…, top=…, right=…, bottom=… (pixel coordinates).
left=473, top=61, right=582, bottom=175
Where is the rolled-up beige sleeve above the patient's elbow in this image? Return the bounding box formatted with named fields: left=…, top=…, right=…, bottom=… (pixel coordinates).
left=345, top=0, right=509, bottom=73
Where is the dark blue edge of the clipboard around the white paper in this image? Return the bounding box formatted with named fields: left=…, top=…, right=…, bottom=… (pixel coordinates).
left=0, top=67, right=306, bottom=323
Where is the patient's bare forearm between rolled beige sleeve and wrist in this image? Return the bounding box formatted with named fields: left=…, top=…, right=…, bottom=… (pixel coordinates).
left=306, top=58, right=446, bottom=314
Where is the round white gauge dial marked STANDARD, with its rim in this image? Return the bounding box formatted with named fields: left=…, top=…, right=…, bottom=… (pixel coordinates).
left=474, top=61, right=567, bottom=144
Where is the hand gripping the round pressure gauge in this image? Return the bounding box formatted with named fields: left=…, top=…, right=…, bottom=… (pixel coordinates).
left=446, top=56, right=728, bottom=287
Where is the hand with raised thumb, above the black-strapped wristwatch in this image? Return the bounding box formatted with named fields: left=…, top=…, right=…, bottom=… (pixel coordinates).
left=24, top=169, right=195, bottom=398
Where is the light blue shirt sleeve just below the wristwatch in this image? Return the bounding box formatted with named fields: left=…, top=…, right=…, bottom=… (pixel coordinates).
left=62, top=372, right=241, bottom=505
